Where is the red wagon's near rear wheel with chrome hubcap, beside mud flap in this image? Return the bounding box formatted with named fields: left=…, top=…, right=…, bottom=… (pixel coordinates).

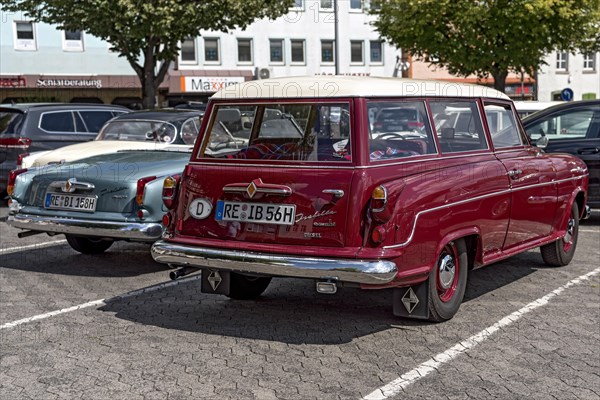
left=428, top=239, right=468, bottom=322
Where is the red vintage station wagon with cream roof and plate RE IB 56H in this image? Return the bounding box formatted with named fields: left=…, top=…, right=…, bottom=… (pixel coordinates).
left=152, top=76, right=589, bottom=321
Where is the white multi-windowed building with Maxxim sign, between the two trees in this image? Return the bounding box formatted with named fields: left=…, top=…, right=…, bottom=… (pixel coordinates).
left=168, top=0, right=400, bottom=102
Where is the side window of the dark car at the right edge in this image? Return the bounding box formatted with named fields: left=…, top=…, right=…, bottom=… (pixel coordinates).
left=527, top=109, right=594, bottom=140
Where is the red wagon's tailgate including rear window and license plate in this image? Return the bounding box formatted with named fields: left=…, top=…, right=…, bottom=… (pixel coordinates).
left=176, top=100, right=354, bottom=247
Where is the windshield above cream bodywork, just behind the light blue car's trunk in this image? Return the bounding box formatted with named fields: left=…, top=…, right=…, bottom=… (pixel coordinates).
left=96, top=120, right=177, bottom=143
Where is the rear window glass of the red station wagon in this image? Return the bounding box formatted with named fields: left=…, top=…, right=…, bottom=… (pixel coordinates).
left=199, top=103, right=351, bottom=161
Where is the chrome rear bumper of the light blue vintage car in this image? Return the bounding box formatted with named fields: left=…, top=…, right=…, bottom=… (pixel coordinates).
left=6, top=214, right=162, bottom=242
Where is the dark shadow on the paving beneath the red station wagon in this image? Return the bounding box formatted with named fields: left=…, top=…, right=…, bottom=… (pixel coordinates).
left=100, top=255, right=541, bottom=344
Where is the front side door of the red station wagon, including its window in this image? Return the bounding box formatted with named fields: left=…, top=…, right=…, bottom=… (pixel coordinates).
left=484, top=102, right=558, bottom=250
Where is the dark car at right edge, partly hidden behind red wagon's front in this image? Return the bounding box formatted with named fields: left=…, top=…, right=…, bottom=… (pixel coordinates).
left=523, top=100, right=600, bottom=208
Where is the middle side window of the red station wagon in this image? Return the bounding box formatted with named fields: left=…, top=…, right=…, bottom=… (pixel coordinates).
left=429, top=100, right=488, bottom=153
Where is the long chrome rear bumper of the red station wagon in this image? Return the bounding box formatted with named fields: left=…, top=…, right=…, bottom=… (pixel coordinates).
left=151, top=240, right=398, bottom=285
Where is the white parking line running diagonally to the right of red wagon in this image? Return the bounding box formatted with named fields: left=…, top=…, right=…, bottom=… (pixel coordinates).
left=363, top=268, right=600, bottom=400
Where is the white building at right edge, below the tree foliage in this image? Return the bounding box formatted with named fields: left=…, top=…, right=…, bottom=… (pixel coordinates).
left=537, top=52, right=600, bottom=101
